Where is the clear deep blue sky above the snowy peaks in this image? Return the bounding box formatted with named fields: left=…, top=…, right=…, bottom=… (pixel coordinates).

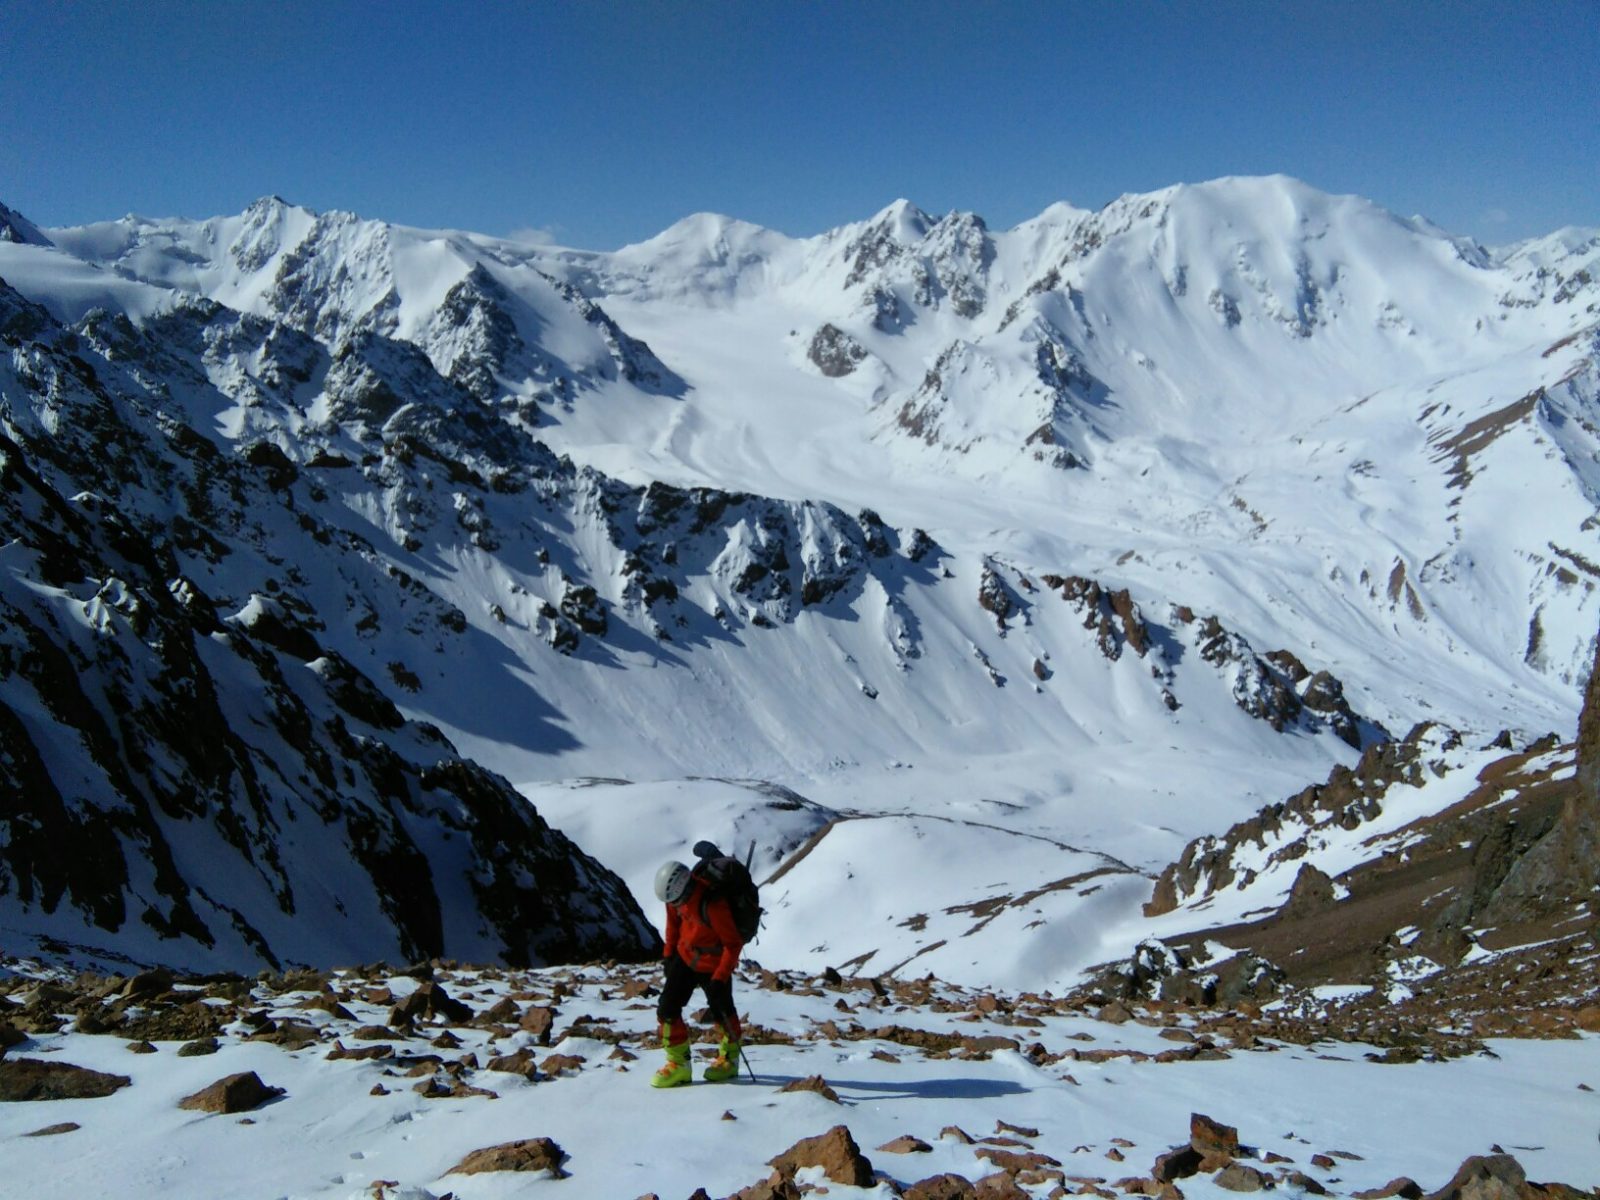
left=0, top=0, right=1600, bottom=250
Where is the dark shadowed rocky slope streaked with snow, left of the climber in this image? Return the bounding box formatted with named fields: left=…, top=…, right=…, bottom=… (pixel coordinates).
left=0, top=285, right=656, bottom=968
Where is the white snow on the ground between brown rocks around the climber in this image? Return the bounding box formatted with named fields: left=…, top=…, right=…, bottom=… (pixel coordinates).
left=0, top=973, right=1600, bottom=1200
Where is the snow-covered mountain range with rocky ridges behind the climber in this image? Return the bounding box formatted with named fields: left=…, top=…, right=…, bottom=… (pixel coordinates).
left=0, top=178, right=1600, bottom=987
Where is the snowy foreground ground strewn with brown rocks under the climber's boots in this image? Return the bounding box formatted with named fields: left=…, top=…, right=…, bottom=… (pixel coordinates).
left=0, top=960, right=1600, bottom=1200
